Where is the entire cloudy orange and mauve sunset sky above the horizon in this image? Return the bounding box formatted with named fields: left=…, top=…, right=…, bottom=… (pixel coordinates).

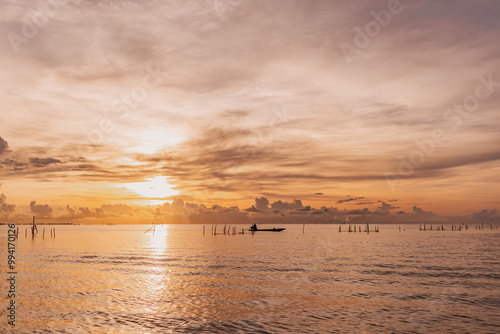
left=0, top=0, right=500, bottom=223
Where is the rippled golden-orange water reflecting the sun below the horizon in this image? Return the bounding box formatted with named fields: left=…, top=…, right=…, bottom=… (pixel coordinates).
left=0, top=225, right=500, bottom=333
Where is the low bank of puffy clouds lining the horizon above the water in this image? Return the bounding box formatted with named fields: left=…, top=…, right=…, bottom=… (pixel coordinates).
left=0, top=194, right=500, bottom=224
